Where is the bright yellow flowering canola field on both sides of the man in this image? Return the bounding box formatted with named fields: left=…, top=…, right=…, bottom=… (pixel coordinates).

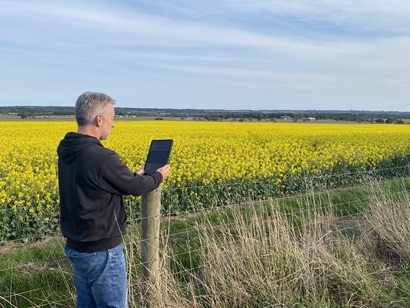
left=0, top=120, right=410, bottom=239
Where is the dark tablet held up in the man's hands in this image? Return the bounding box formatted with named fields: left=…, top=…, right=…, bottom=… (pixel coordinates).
left=144, top=139, right=173, bottom=174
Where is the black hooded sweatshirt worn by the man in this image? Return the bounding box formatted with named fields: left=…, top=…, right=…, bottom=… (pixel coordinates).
left=57, top=133, right=162, bottom=252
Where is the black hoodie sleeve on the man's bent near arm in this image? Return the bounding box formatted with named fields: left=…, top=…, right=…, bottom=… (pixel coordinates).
left=100, top=152, right=162, bottom=196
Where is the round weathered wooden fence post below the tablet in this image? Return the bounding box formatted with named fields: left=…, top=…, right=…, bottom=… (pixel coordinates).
left=141, top=186, right=161, bottom=291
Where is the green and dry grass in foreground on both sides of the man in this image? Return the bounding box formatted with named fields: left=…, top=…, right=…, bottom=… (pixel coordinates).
left=0, top=179, right=410, bottom=307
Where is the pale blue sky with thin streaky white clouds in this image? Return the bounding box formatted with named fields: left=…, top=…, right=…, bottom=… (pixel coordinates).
left=0, top=0, right=410, bottom=111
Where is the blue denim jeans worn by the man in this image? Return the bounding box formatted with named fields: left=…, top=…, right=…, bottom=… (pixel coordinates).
left=65, top=244, right=128, bottom=308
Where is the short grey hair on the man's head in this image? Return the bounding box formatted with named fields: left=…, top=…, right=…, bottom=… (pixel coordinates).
left=75, top=92, right=115, bottom=126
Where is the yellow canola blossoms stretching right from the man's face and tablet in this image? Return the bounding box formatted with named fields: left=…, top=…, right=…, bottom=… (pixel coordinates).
left=105, top=121, right=410, bottom=186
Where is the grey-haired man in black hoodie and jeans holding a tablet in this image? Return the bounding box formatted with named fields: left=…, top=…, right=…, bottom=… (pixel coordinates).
left=57, top=92, right=170, bottom=307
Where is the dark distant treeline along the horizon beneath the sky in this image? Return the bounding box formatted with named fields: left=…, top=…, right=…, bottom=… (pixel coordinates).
left=0, top=106, right=410, bottom=123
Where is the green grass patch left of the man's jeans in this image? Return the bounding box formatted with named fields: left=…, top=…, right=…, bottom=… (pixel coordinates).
left=0, top=238, right=74, bottom=307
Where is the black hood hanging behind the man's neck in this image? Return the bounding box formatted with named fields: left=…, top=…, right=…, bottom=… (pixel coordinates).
left=57, top=132, right=103, bottom=163
